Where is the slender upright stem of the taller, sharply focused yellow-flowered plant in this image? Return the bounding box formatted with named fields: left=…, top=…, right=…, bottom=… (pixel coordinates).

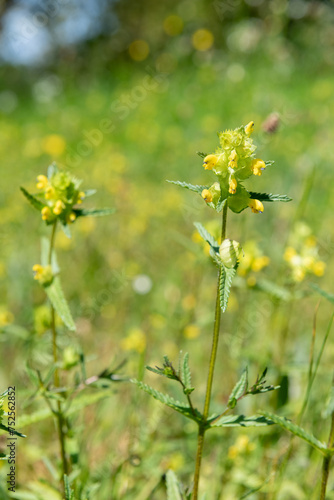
left=192, top=203, right=227, bottom=500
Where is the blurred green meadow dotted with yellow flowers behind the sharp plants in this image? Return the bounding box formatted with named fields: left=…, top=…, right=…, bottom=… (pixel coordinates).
left=0, top=0, right=334, bottom=500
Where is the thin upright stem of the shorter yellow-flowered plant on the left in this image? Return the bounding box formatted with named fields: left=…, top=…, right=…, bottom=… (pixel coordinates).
left=48, top=221, right=68, bottom=486
